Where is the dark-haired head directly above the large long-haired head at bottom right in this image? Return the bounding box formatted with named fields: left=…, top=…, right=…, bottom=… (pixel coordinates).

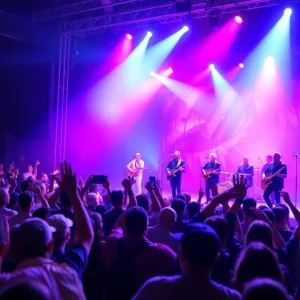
left=245, top=221, right=274, bottom=249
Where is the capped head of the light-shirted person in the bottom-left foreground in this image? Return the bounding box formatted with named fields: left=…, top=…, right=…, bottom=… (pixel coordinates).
left=12, top=218, right=55, bottom=260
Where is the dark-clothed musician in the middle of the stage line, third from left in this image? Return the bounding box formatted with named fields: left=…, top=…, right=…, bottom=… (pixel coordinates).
left=202, top=153, right=221, bottom=204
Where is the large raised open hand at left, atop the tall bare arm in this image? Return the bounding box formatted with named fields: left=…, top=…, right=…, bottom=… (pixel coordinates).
left=56, top=161, right=78, bottom=195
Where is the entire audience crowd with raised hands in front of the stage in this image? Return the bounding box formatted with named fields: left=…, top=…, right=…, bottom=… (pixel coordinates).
left=0, top=161, right=300, bottom=300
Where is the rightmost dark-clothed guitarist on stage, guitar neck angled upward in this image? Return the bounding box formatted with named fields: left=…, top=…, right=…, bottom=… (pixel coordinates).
left=262, top=152, right=287, bottom=208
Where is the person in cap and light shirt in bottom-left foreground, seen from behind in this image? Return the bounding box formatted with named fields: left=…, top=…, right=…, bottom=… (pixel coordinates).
left=0, top=218, right=85, bottom=300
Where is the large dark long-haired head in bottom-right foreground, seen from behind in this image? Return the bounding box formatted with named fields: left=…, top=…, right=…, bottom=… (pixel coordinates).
left=234, top=243, right=283, bottom=291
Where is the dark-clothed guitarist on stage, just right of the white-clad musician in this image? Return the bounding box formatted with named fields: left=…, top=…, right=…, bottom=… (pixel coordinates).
left=166, top=151, right=186, bottom=198
